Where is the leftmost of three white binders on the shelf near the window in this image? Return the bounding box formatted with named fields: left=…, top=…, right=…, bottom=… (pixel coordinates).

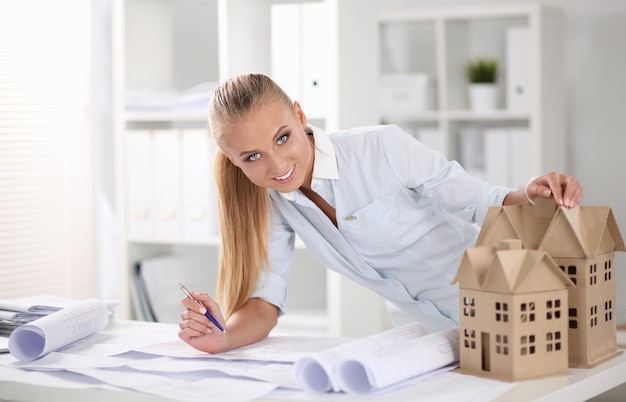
left=126, top=130, right=155, bottom=235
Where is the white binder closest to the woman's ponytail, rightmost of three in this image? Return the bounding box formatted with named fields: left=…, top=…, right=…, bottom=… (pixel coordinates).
left=181, top=129, right=218, bottom=237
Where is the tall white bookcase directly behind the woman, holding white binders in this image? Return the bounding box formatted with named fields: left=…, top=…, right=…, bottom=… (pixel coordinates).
left=112, top=0, right=382, bottom=335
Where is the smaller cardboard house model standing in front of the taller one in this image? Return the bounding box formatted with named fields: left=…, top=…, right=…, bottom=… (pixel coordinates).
left=454, top=240, right=572, bottom=381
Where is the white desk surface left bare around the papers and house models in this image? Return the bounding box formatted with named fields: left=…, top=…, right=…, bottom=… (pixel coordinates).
left=0, top=320, right=626, bottom=402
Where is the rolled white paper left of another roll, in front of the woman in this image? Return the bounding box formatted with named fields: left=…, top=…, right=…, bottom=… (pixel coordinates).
left=294, top=322, right=428, bottom=392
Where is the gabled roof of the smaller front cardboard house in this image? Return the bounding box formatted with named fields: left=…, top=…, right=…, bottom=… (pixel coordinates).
left=452, top=240, right=573, bottom=294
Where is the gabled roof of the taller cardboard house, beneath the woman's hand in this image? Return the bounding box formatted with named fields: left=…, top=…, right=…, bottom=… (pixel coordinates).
left=476, top=198, right=626, bottom=258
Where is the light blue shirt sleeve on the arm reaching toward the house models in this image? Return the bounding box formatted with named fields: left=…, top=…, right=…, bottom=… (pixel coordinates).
left=381, top=125, right=514, bottom=224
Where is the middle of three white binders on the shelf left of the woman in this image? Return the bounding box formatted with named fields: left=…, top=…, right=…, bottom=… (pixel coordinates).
left=153, top=130, right=182, bottom=237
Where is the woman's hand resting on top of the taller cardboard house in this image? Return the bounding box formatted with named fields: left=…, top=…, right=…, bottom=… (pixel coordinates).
left=524, top=172, right=583, bottom=208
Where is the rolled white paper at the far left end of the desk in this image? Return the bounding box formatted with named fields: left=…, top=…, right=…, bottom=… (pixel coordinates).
left=9, top=299, right=109, bottom=360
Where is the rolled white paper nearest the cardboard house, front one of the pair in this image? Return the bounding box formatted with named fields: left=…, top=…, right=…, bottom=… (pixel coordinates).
left=336, top=328, right=459, bottom=394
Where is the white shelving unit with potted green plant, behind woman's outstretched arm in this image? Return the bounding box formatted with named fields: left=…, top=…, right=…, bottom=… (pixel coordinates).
left=379, top=2, right=566, bottom=186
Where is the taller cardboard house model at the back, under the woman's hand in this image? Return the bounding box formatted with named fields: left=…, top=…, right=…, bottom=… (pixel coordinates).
left=457, top=198, right=625, bottom=374
